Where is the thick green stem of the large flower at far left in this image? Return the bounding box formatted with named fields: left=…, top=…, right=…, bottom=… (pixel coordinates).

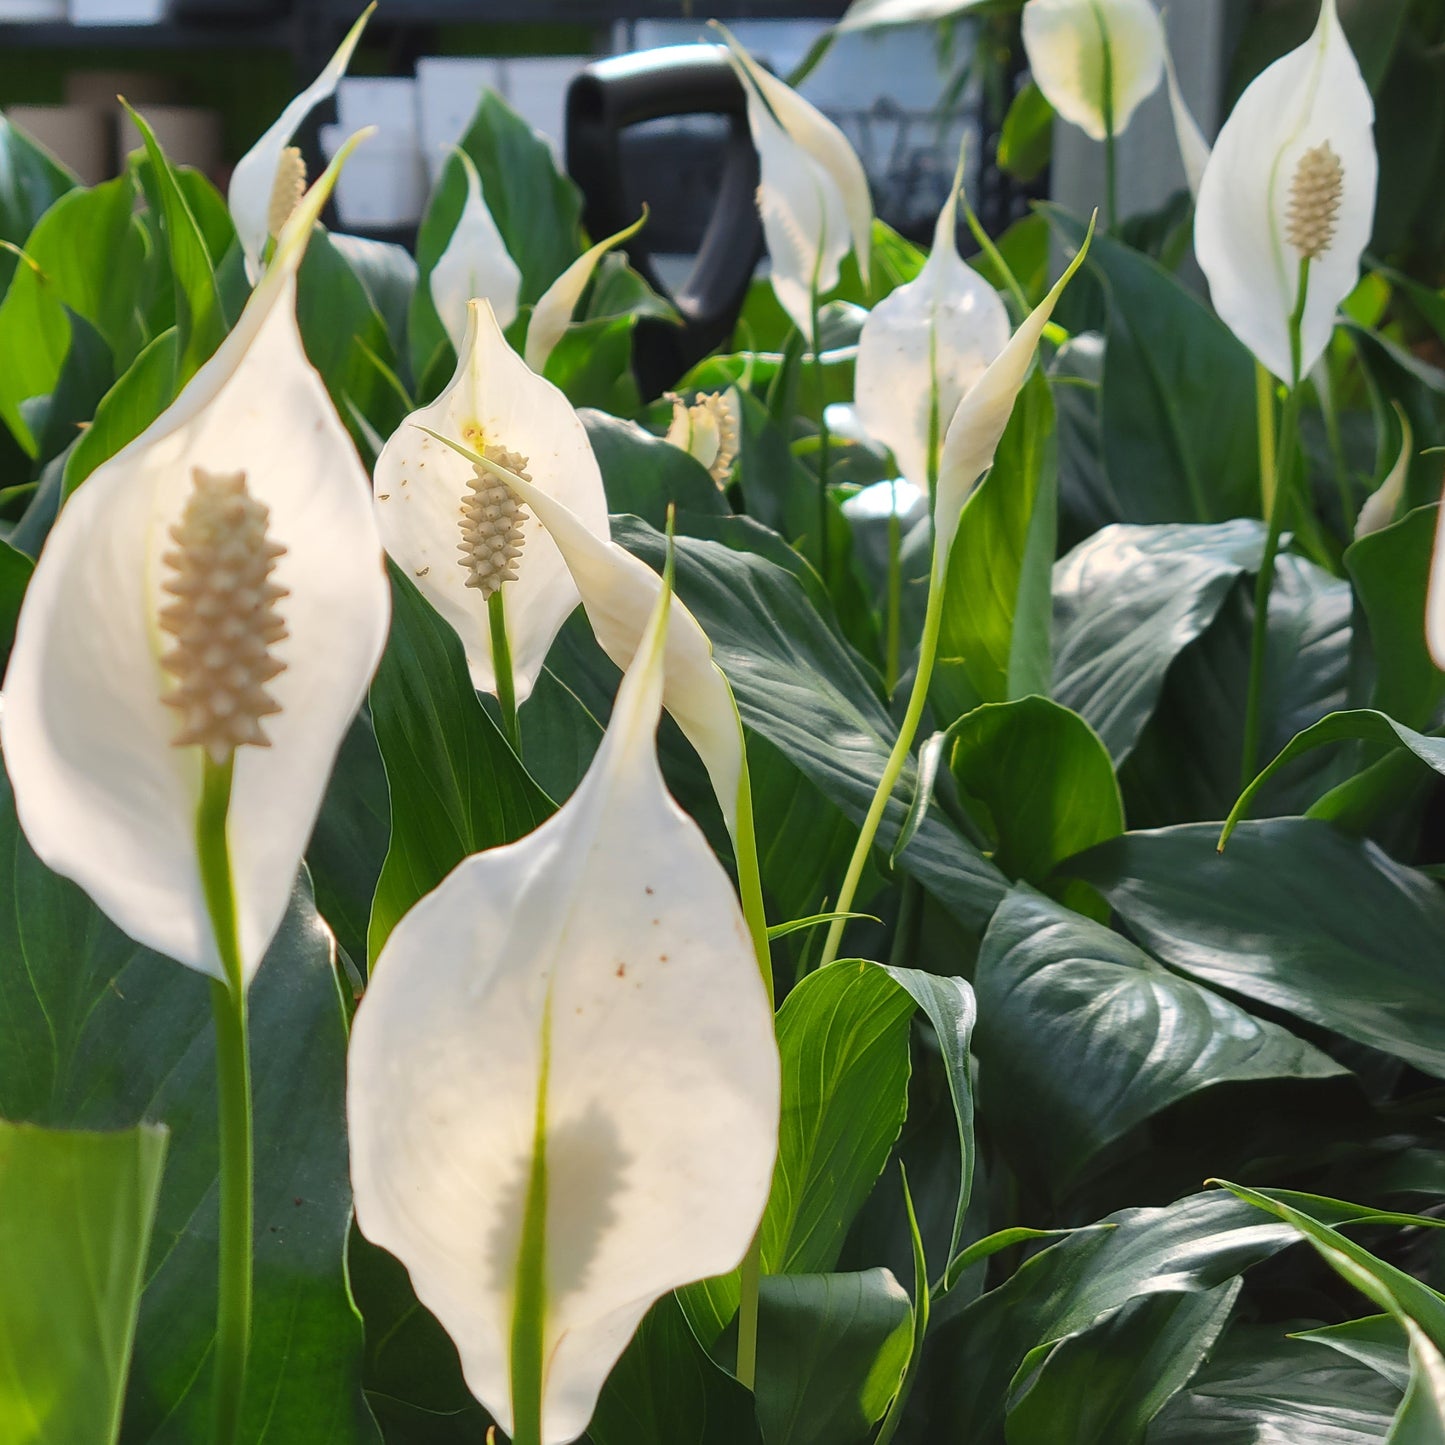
left=195, top=754, right=253, bottom=1445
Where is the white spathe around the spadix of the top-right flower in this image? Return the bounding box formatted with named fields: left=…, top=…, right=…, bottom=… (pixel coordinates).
left=1194, top=0, right=1380, bottom=384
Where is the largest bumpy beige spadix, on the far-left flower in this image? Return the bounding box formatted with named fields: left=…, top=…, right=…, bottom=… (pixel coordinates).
left=160, top=467, right=286, bottom=763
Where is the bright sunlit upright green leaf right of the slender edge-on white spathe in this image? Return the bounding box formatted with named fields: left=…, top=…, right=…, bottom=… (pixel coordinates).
left=929, top=371, right=1058, bottom=723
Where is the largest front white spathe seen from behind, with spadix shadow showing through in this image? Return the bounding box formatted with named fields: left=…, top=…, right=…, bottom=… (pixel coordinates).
left=347, top=569, right=779, bottom=1445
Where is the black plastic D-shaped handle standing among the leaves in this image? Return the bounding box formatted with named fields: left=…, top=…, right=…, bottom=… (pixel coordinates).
left=566, top=45, right=763, bottom=399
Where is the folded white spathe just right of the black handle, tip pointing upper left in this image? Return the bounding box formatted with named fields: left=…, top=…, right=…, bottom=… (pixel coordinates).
left=712, top=20, right=873, bottom=342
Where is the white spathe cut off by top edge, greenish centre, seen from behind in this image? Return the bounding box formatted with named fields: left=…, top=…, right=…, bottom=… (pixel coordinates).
left=1023, top=0, right=1165, bottom=140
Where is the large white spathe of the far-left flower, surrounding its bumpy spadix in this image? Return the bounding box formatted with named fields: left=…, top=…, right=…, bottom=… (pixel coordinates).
left=0, top=135, right=390, bottom=980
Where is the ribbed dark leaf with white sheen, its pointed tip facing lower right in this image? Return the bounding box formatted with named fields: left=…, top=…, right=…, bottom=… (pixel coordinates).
left=975, top=887, right=1345, bottom=1196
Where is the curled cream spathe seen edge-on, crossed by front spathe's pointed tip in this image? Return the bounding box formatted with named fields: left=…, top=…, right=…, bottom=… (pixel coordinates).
left=421, top=421, right=746, bottom=840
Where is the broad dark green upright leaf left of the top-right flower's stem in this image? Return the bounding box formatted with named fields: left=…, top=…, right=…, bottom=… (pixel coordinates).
left=1048, top=207, right=1260, bottom=523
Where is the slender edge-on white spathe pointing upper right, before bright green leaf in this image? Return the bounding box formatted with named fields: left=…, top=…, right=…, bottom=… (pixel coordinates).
left=933, top=210, right=1094, bottom=587
